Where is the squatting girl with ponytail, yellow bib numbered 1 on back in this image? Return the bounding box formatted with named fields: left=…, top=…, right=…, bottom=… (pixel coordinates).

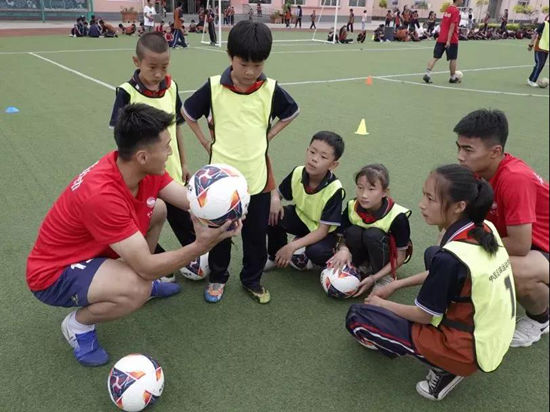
left=346, top=165, right=515, bottom=400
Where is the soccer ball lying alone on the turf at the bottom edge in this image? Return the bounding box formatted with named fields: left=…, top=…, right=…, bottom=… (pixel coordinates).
left=107, top=353, right=164, bottom=412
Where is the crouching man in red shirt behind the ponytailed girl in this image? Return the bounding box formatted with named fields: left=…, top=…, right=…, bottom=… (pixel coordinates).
left=454, top=110, right=549, bottom=347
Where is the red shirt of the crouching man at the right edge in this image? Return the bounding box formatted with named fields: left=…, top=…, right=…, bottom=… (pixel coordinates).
left=487, top=153, right=549, bottom=252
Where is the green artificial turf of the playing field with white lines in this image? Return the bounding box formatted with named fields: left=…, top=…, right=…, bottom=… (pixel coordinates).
left=0, top=32, right=549, bottom=411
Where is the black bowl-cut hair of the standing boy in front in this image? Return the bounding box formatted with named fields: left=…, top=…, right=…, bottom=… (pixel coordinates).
left=227, top=20, right=273, bottom=63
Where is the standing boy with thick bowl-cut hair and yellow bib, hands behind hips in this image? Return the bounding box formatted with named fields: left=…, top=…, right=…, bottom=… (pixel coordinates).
left=183, top=20, right=299, bottom=303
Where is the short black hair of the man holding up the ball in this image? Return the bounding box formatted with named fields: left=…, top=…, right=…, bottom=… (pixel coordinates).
left=114, top=103, right=175, bottom=160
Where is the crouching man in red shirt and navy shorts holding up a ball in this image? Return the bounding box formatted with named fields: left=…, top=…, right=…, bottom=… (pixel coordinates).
left=27, top=104, right=242, bottom=366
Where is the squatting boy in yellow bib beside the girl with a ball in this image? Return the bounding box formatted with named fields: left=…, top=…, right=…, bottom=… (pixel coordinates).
left=265, top=131, right=344, bottom=270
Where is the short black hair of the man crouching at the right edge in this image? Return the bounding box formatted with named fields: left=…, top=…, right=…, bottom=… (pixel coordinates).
left=453, top=109, right=508, bottom=150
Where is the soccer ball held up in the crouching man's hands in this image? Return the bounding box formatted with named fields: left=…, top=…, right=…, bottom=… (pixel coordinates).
left=187, top=164, right=250, bottom=227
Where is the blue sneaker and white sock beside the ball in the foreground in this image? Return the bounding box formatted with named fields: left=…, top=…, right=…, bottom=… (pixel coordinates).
left=61, top=314, right=109, bottom=366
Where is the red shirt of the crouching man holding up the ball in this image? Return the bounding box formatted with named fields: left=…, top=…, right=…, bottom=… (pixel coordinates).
left=27, top=151, right=172, bottom=291
